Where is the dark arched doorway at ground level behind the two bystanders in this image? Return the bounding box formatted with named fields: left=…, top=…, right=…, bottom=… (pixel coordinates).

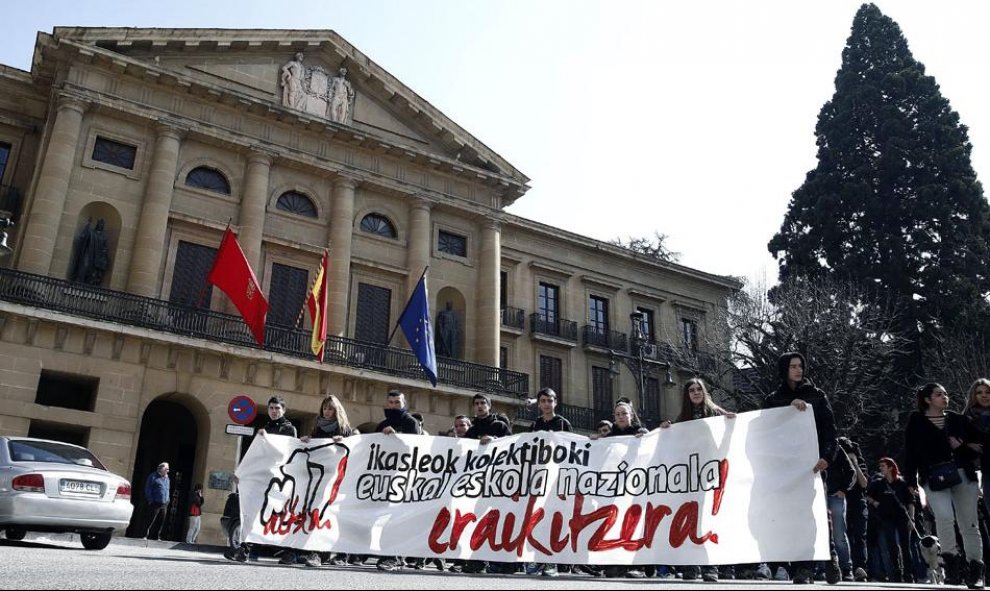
left=127, top=399, right=198, bottom=541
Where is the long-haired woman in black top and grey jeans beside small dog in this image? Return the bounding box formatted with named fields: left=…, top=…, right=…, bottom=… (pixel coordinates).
left=904, top=383, right=983, bottom=589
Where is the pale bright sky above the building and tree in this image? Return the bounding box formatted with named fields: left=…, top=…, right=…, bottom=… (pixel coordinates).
left=0, top=0, right=990, bottom=283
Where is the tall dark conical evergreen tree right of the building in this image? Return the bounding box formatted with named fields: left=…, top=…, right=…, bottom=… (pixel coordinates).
left=768, top=4, right=990, bottom=370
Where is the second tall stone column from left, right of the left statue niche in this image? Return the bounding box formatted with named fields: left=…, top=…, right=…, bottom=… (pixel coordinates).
left=127, top=123, right=184, bottom=297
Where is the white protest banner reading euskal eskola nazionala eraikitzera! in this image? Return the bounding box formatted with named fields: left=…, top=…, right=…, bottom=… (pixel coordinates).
left=237, top=407, right=829, bottom=565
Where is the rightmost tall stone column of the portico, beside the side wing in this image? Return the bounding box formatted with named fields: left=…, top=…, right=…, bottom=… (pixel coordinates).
left=475, top=219, right=502, bottom=367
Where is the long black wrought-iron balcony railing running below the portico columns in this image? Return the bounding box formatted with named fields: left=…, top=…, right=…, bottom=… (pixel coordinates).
left=0, top=269, right=529, bottom=397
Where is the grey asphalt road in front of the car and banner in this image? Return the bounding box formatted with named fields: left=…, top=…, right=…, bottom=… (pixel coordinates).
left=0, top=535, right=940, bottom=591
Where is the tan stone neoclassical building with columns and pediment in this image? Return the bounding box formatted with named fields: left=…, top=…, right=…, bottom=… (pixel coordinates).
left=0, top=28, right=739, bottom=542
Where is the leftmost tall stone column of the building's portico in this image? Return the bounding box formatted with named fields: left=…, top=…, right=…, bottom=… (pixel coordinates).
left=17, top=95, right=88, bottom=275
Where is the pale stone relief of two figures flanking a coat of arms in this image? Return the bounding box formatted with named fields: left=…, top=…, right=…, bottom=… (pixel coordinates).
left=281, top=53, right=355, bottom=123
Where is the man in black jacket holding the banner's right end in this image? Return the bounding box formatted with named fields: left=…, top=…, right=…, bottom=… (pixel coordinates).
left=763, top=351, right=842, bottom=585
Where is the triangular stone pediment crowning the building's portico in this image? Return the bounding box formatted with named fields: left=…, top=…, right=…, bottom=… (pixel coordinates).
left=36, top=27, right=529, bottom=184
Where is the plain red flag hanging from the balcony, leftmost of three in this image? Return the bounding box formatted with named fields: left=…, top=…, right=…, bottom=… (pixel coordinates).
left=206, top=227, right=268, bottom=347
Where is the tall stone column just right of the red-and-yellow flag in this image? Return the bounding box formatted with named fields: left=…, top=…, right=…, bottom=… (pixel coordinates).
left=327, top=177, right=357, bottom=336
